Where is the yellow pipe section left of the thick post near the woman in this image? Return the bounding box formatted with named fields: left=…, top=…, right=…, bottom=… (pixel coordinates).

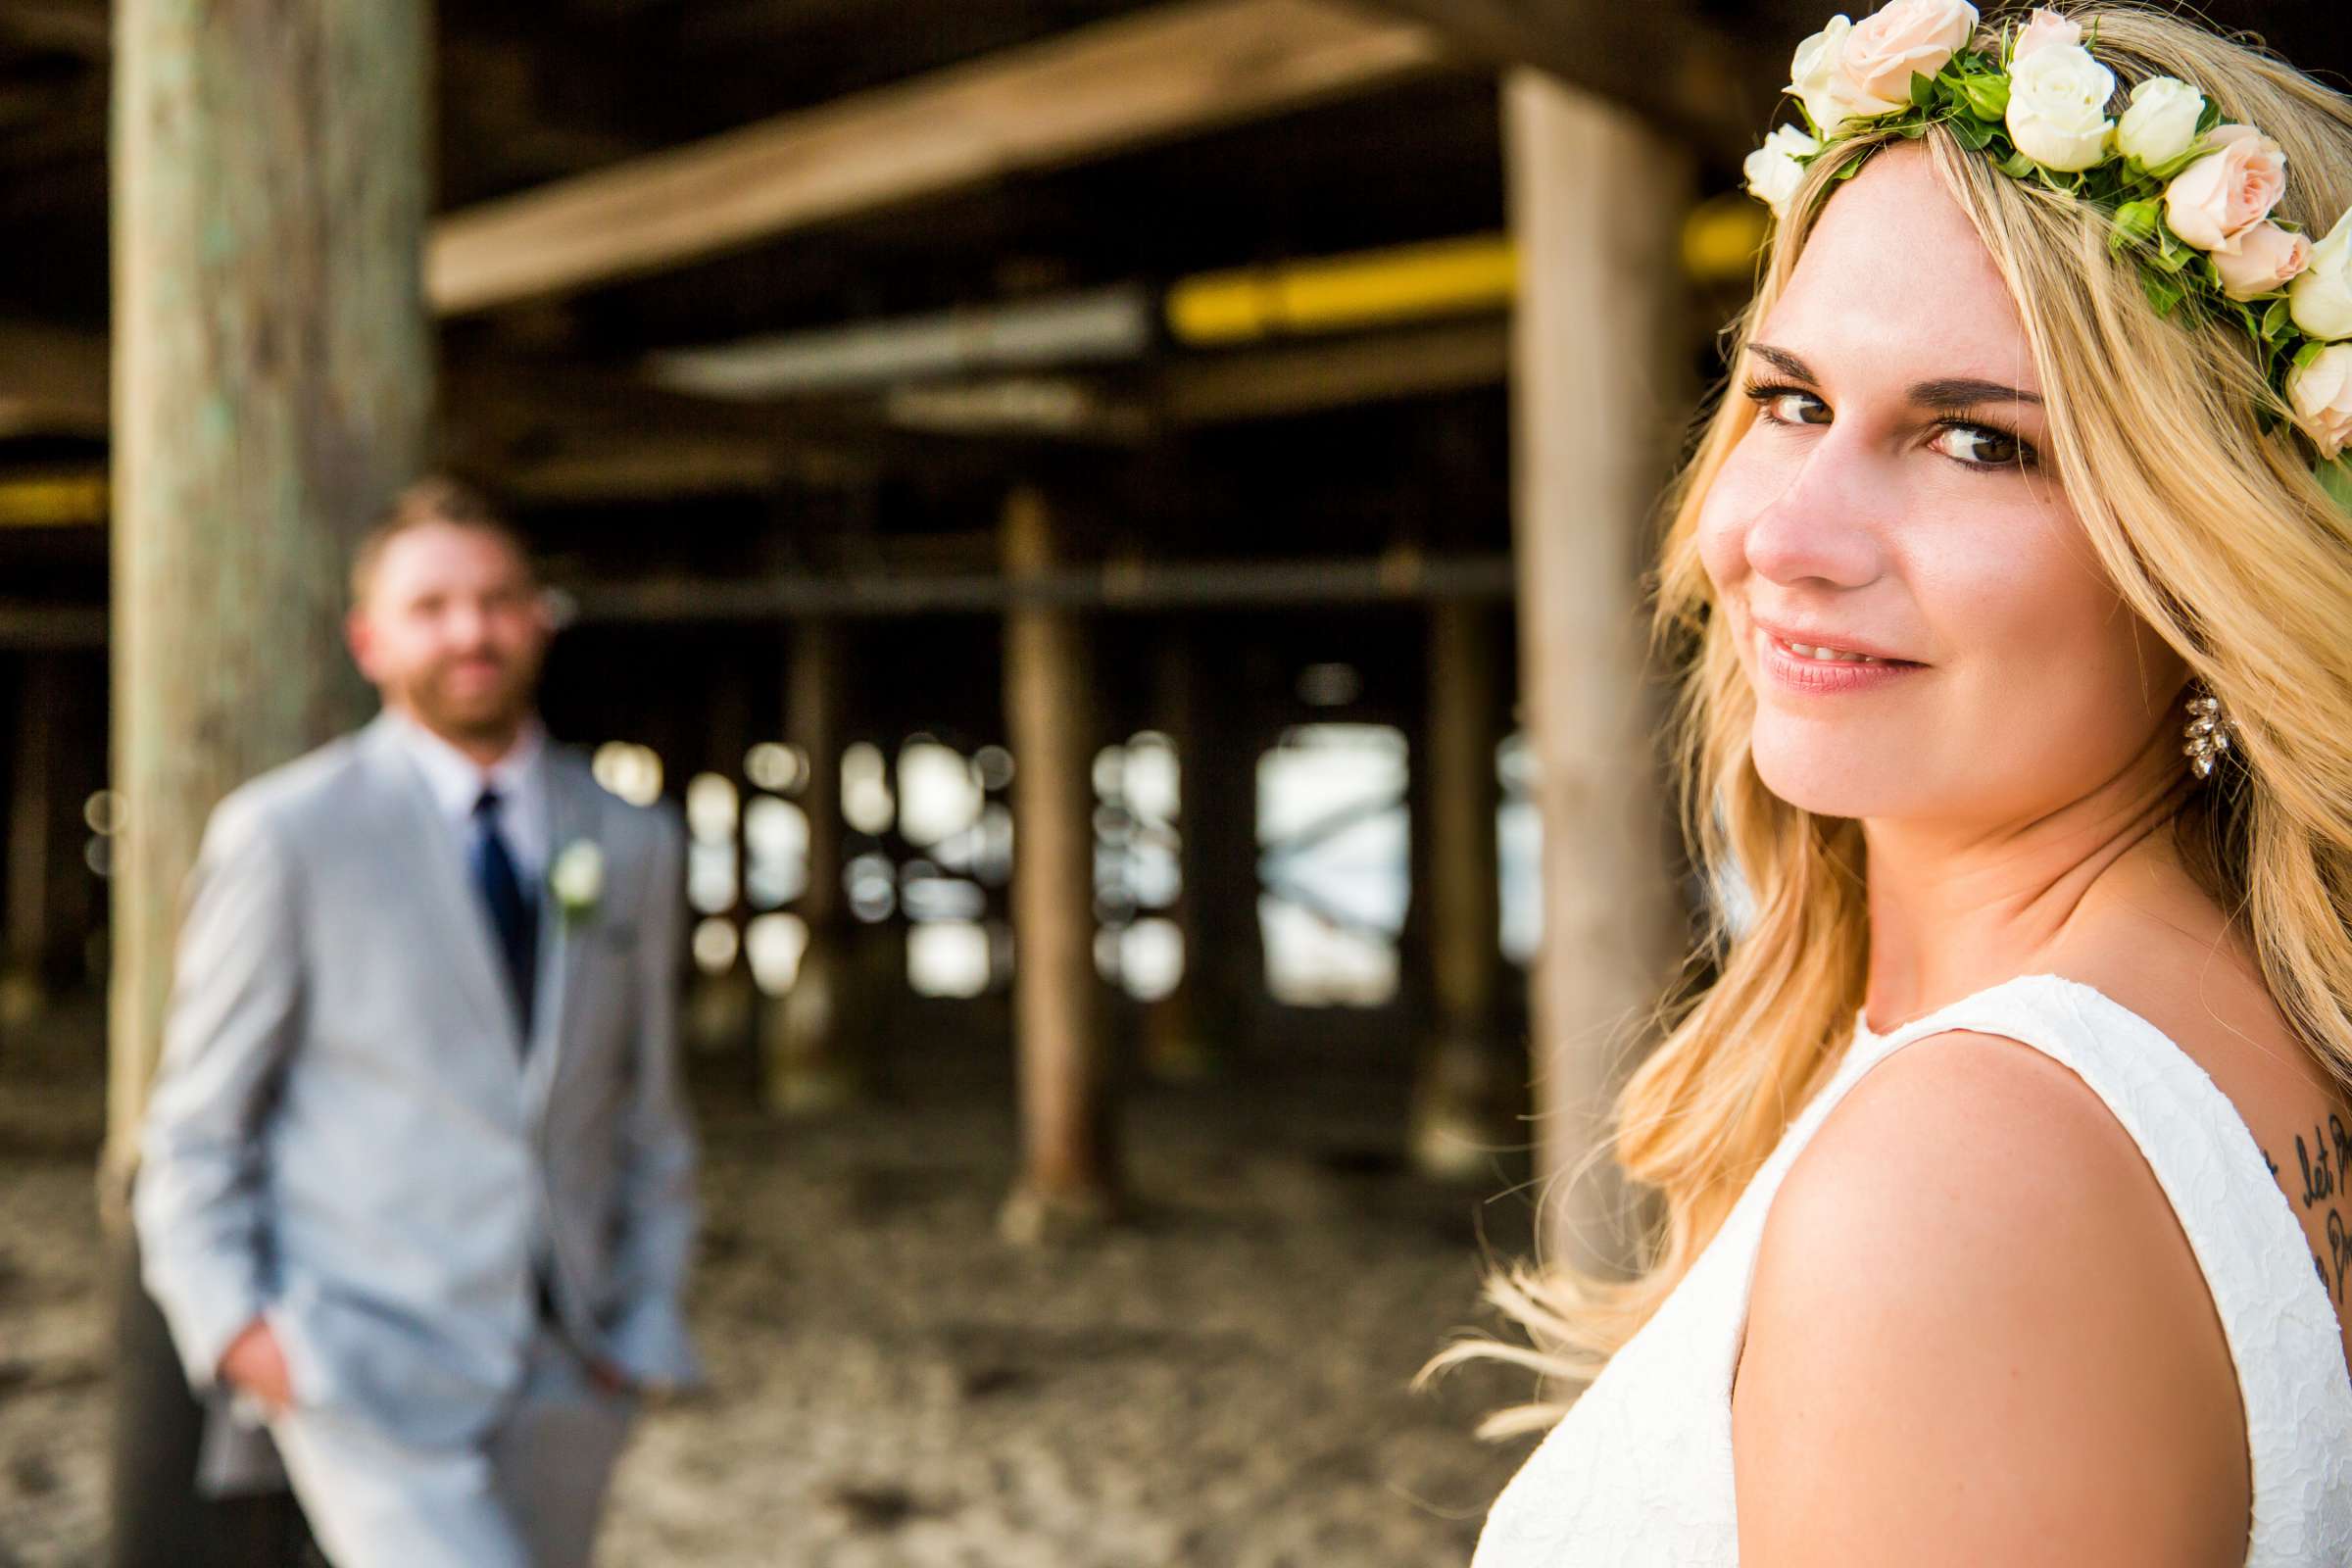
left=1166, top=235, right=1519, bottom=343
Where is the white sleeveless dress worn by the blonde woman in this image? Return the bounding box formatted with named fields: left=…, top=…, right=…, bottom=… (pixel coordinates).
left=1472, top=976, right=2352, bottom=1568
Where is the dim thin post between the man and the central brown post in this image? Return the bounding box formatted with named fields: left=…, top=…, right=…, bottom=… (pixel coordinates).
left=760, top=615, right=870, bottom=1116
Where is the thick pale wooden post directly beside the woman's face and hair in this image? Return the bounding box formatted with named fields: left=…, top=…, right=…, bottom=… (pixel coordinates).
left=1503, top=71, right=1693, bottom=1267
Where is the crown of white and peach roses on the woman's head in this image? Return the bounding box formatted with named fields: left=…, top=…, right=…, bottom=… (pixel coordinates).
left=1745, top=0, right=2352, bottom=511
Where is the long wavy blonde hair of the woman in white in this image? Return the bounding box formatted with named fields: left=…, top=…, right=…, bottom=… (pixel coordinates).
left=1430, top=2, right=2352, bottom=1434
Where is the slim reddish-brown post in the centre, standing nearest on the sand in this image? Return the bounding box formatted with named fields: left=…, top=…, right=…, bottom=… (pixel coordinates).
left=1002, top=487, right=1119, bottom=1242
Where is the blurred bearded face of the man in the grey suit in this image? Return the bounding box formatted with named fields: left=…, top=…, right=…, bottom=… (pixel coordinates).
left=351, top=522, right=553, bottom=743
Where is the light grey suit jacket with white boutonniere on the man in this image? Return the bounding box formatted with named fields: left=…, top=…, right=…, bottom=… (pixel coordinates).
left=134, top=719, right=699, bottom=1446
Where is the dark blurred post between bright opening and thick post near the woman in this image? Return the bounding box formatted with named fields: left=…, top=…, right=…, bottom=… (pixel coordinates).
left=1411, top=600, right=1524, bottom=1180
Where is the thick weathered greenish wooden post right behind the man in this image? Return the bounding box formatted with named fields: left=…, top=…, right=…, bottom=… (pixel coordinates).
left=106, top=0, right=433, bottom=1563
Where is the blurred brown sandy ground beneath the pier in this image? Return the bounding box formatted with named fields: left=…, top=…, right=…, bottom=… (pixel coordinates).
left=0, top=1001, right=1527, bottom=1568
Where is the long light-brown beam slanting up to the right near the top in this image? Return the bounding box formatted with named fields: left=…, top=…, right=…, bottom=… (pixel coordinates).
left=425, top=0, right=1440, bottom=315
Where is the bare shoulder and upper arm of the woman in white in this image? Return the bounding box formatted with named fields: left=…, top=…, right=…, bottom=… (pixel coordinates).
left=1734, top=1032, right=2248, bottom=1568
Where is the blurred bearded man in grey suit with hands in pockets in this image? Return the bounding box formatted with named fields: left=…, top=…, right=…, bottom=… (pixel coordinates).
left=134, top=479, right=696, bottom=1568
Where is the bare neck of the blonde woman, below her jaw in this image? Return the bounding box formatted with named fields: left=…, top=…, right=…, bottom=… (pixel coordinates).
left=1863, top=741, right=2185, bottom=1025
